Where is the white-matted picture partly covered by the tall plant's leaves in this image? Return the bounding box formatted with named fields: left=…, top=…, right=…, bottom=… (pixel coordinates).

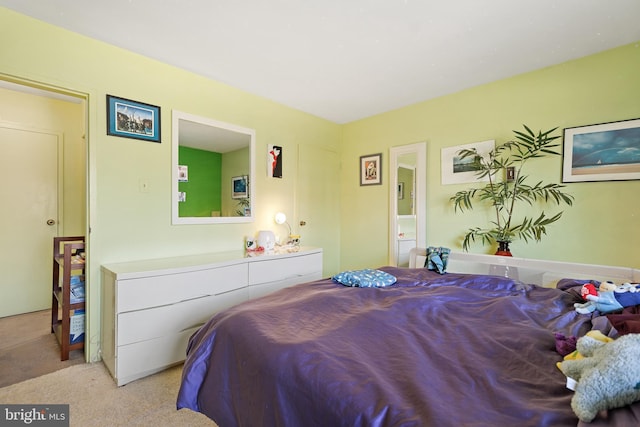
left=440, top=139, right=496, bottom=185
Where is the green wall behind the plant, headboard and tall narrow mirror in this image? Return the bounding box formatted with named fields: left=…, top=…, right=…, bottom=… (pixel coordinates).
left=341, top=43, right=640, bottom=269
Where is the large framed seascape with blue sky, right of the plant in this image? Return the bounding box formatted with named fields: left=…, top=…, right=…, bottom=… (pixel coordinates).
left=562, top=119, right=640, bottom=182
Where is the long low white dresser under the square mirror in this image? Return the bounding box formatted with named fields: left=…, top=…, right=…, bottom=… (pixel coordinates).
left=101, top=247, right=322, bottom=386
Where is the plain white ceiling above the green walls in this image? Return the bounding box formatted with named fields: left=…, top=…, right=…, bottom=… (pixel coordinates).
left=0, top=0, right=640, bottom=123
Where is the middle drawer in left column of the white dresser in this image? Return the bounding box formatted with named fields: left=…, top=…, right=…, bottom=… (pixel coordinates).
left=117, top=287, right=249, bottom=345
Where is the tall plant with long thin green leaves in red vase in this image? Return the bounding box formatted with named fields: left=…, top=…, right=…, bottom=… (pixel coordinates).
left=450, top=125, right=574, bottom=255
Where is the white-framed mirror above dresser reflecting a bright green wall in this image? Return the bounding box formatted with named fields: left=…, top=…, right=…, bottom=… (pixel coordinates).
left=171, top=110, right=255, bottom=224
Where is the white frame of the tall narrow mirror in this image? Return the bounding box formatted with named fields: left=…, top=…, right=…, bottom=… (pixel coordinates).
left=388, top=142, right=427, bottom=265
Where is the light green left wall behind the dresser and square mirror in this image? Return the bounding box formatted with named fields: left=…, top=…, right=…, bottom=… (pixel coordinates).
left=0, top=8, right=341, bottom=360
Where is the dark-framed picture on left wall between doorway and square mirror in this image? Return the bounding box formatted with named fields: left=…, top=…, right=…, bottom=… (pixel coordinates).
left=107, top=95, right=160, bottom=143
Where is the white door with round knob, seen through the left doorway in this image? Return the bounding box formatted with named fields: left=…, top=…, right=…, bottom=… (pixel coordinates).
left=0, top=123, right=62, bottom=317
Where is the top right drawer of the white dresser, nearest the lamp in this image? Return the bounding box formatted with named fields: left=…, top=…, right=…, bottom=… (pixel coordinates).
left=249, top=253, right=322, bottom=286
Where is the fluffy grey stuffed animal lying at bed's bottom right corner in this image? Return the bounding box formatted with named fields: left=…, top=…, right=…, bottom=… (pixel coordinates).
left=558, top=334, right=640, bottom=422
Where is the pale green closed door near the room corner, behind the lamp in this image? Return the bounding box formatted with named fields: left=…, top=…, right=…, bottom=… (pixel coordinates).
left=298, top=145, right=340, bottom=271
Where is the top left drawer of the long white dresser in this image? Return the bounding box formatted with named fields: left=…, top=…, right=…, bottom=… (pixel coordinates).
left=116, top=264, right=247, bottom=313
